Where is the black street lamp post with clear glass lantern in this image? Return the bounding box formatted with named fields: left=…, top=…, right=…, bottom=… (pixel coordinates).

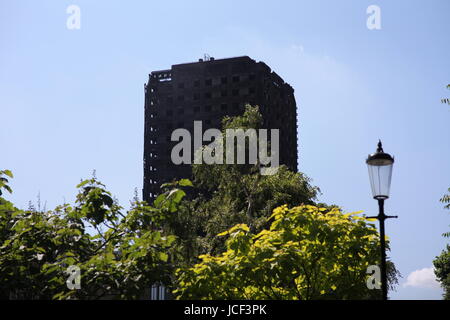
left=366, top=140, right=397, bottom=300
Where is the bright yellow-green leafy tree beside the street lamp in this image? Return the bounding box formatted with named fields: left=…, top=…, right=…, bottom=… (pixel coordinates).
left=174, top=205, right=397, bottom=300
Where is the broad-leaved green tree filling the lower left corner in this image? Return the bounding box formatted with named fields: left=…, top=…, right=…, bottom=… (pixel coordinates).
left=0, top=172, right=185, bottom=299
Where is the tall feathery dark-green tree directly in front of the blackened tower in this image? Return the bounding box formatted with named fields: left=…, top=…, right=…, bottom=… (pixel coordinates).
left=166, top=105, right=320, bottom=264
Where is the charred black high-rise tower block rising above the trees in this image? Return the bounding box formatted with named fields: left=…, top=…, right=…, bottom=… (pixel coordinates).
left=143, top=56, right=297, bottom=201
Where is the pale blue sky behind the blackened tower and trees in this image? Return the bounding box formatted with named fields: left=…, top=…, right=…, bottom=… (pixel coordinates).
left=0, top=0, right=450, bottom=299
